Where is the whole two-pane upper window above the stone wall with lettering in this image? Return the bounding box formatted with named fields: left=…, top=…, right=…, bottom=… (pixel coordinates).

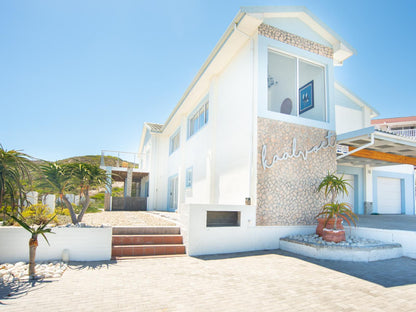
left=267, top=51, right=327, bottom=121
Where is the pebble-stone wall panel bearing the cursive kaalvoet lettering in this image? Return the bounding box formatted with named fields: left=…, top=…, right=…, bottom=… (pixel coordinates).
left=256, top=117, right=336, bottom=225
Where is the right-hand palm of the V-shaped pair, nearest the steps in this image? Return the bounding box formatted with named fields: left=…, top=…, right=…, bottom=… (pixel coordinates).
left=69, top=163, right=111, bottom=222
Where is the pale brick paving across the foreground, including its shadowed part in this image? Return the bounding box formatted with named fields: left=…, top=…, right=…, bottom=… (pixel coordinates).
left=0, top=250, right=416, bottom=311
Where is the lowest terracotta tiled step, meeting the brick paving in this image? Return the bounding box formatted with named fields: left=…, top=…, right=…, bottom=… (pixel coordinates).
left=112, top=244, right=185, bottom=258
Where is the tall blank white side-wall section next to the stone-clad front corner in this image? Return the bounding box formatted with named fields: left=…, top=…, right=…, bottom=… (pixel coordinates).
left=212, top=43, right=257, bottom=204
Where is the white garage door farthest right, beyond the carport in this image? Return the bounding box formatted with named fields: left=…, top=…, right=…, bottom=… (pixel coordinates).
left=377, top=177, right=402, bottom=214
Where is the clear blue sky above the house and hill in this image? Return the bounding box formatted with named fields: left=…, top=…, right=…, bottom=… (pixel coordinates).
left=0, top=0, right=416, bottom=161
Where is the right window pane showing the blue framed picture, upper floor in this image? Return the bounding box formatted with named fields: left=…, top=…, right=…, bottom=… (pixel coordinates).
left=299, top=60, right=326, bottom=121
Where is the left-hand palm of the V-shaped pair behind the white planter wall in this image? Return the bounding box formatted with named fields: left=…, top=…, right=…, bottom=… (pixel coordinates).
left=38, top=162, right=78, bottom=224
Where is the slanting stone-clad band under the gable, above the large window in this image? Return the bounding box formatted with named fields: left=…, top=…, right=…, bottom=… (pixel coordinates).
left=258, top=24, right=334, bottom=59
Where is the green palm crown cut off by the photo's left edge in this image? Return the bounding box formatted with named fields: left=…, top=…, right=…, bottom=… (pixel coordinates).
left=0, top=144, right=35, bottom=216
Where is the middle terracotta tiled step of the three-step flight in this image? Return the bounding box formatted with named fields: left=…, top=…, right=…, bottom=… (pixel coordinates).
left=113, top=235, right=183, bottom=245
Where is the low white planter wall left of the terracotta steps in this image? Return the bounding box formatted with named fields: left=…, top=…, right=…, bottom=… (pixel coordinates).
left=0, top=226, right=112, bottom=263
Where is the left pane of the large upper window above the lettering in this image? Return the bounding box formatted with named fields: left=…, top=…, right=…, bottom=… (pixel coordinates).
left=267, top=51, right=297, bottom=116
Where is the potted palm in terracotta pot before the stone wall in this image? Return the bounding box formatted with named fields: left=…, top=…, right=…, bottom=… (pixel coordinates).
left=316, top=172, right=358, bottom=242
